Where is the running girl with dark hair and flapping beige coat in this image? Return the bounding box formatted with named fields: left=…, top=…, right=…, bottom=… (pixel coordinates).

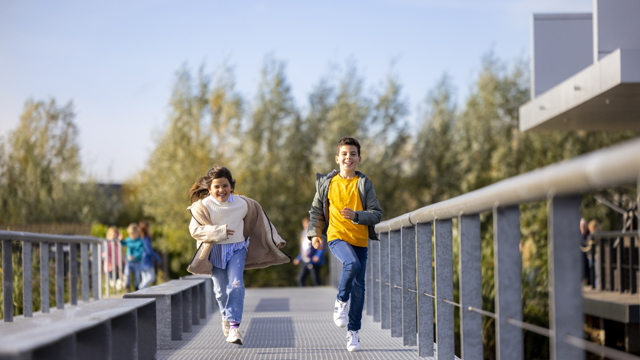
left=187, top=166, right=291, bottom=345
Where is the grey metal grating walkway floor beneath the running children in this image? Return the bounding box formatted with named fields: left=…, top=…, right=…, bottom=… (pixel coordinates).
left=158, top=287, right=435, bottom=360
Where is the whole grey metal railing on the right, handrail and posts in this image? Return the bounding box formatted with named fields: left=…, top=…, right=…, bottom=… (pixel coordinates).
left=331, top=139, right=640, bottom=360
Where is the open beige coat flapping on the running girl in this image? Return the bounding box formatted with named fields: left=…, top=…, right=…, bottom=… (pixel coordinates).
left=187, top=195, right=291, bottom=275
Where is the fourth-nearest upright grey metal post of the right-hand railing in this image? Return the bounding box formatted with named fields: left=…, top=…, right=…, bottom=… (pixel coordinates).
left=435, top=219, right=455, bottom=360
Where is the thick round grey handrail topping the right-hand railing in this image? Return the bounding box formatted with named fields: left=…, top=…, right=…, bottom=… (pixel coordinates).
left=375, top=139, right=640, bottom=233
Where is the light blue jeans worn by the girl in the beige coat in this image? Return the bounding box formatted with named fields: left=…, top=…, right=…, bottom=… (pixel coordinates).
left=211, top=248, right=247, bottom=322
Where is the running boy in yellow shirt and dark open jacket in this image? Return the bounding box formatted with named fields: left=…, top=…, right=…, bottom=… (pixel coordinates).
left=307, top=137, right=382, bottom=351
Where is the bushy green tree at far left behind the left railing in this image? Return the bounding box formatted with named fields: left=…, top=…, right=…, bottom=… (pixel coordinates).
left=0, top=99, right=96, bottom=224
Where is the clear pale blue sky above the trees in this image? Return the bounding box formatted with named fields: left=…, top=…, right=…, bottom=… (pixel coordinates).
left=0, top=0, right=592, bottom=182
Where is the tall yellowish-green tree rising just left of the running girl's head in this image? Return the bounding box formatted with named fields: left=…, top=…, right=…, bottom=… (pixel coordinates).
left=127, top=66, right=214, bottom=275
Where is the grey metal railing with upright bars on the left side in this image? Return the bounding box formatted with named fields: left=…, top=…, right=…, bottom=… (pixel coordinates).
left=0, top=231, right=122, bottom=322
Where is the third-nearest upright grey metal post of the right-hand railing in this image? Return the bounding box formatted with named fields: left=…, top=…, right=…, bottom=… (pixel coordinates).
left=458, top=214, right=483, bottom=360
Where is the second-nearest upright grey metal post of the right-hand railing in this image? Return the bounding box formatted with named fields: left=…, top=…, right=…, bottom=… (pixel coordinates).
left=493, top=205, right=524, bottom=360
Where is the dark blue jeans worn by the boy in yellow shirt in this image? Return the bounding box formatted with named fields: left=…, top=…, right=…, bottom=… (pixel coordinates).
left=329, top=239, right=367, bottom=331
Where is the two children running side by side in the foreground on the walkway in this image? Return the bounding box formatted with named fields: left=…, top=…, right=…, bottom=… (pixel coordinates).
left=188, top=137, right=382, bottom=351
